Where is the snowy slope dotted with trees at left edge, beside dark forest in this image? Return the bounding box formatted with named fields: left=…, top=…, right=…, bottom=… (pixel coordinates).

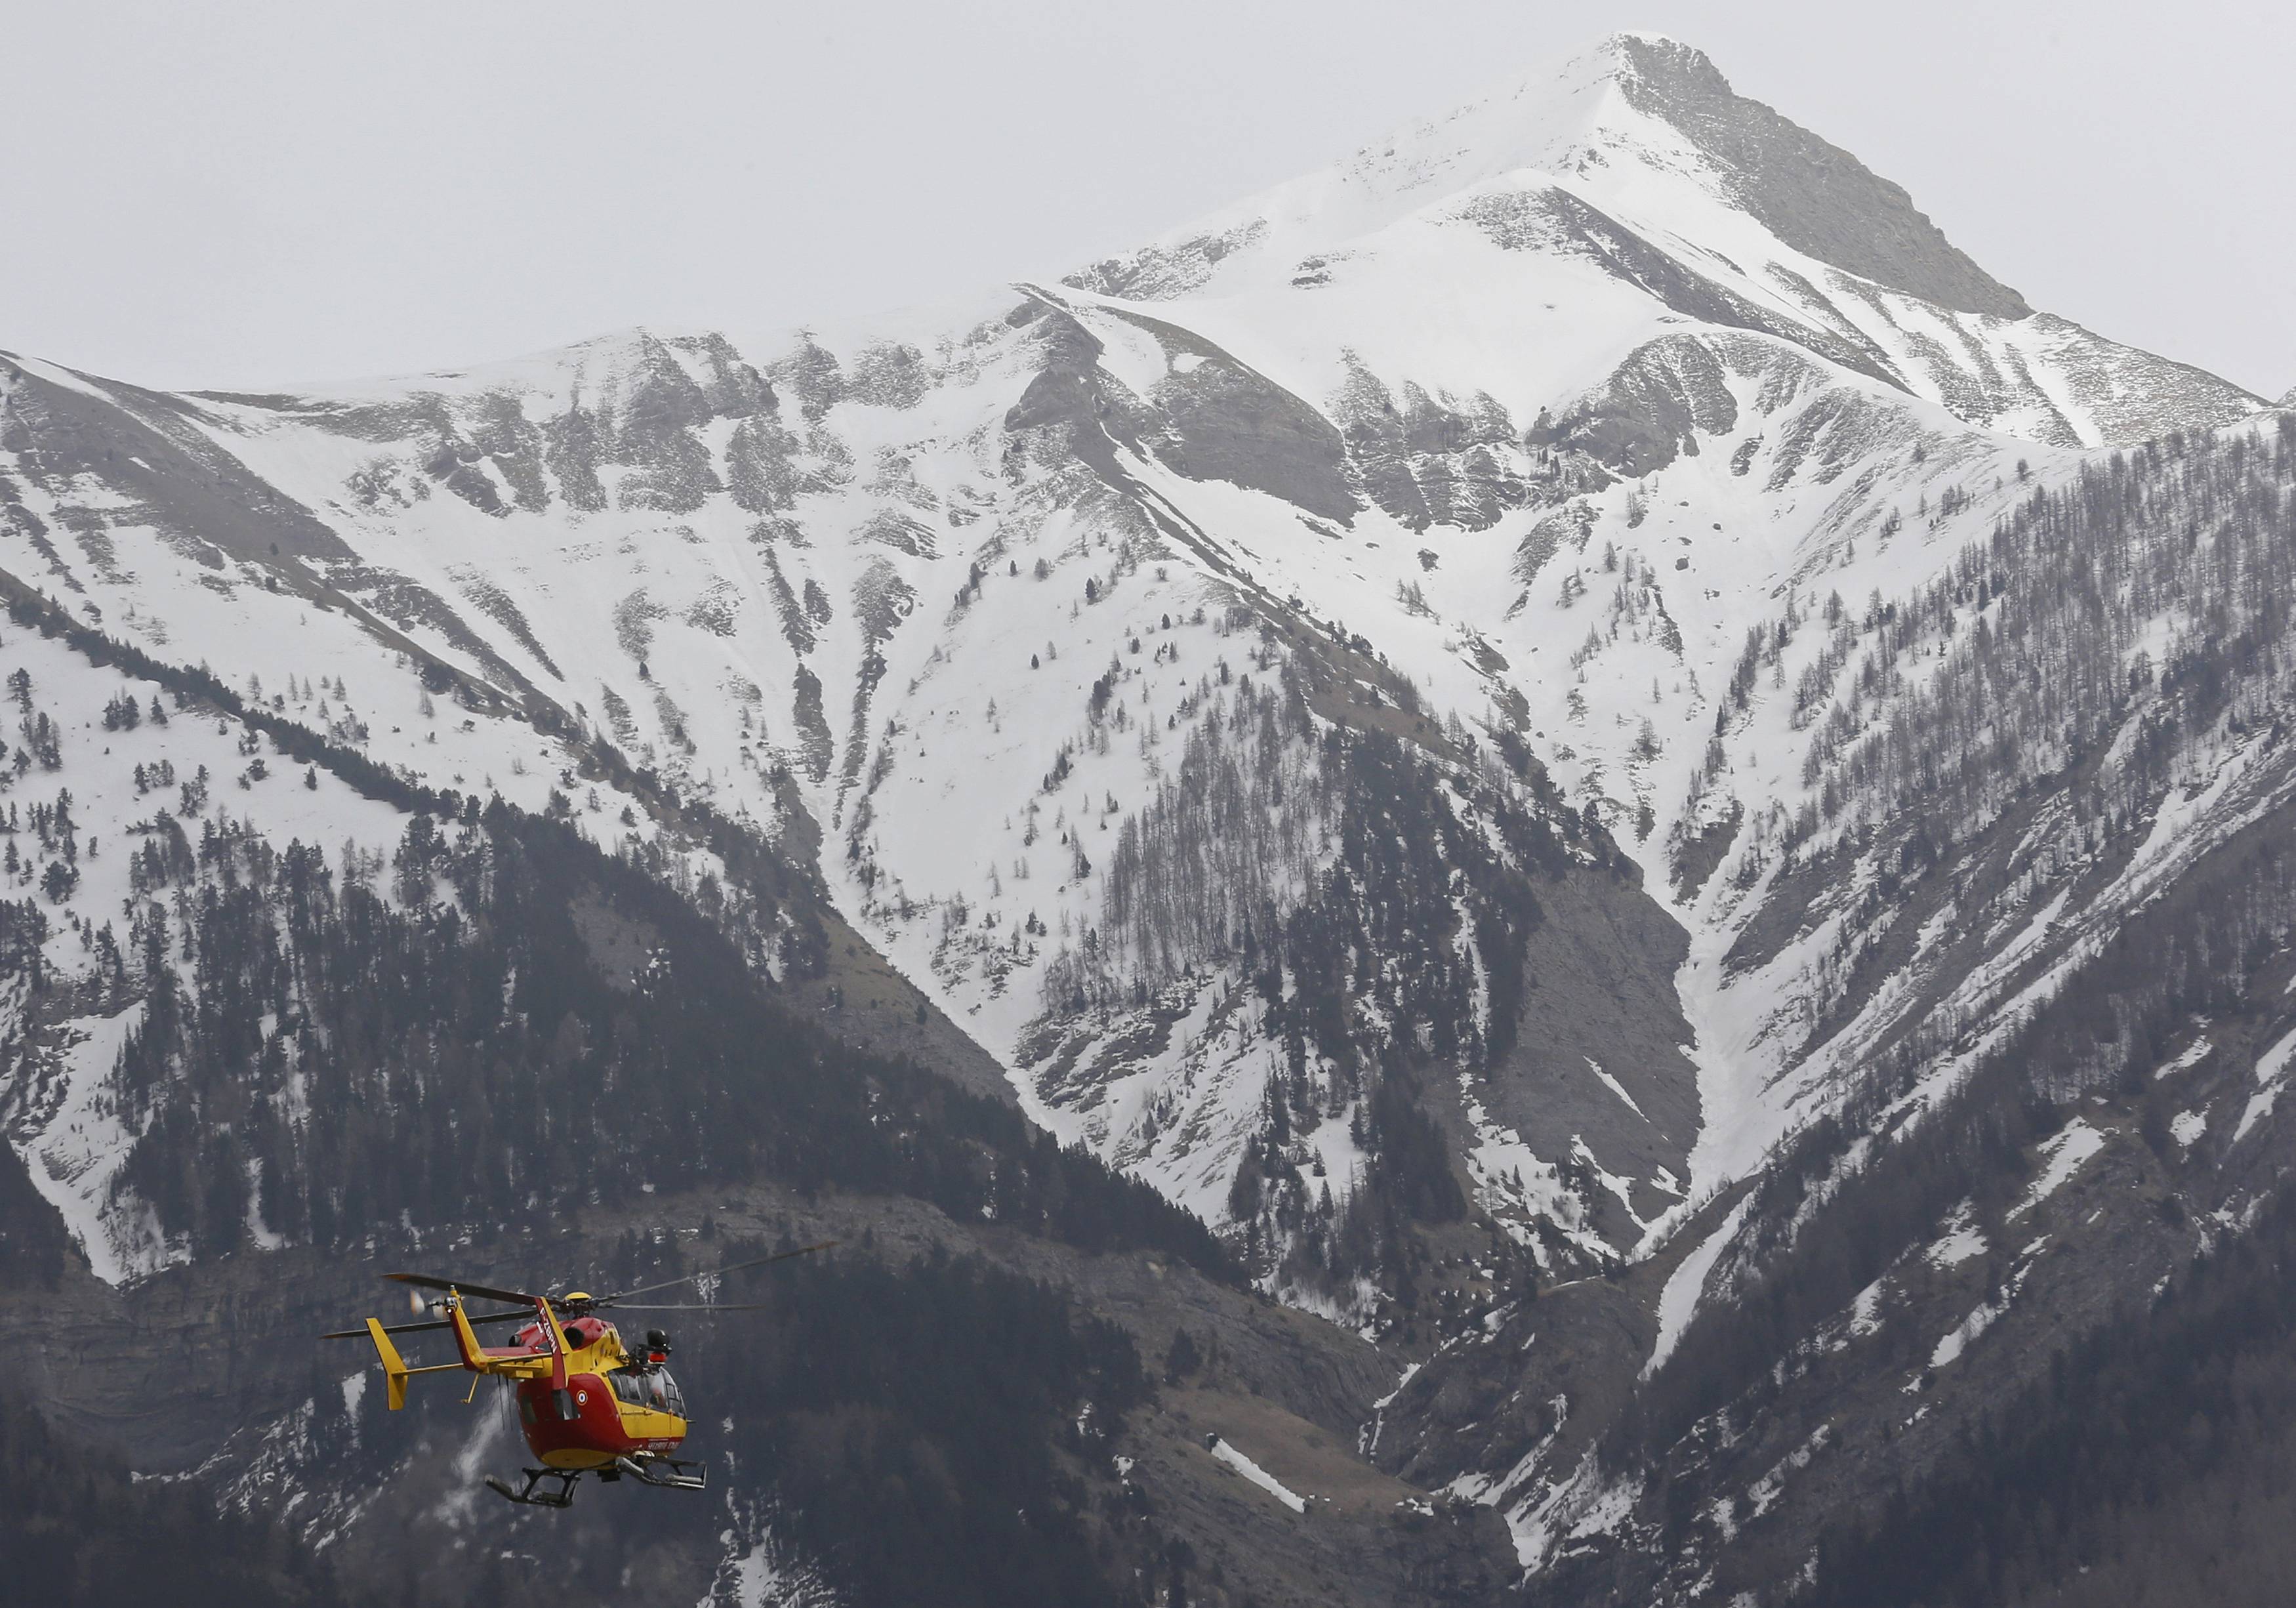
left=0, top=600, right=689, bottom=1284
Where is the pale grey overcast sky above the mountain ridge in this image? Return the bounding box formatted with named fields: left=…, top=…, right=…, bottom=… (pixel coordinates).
left=0, top=0, right=2296, bottom=395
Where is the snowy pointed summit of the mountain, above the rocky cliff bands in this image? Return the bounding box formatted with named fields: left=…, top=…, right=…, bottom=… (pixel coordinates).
left=1073, top=35, right=2259, bottom=445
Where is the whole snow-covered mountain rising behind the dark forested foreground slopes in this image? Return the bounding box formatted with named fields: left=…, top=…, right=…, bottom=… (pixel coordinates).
left=0, top=35, right=2296, bottom=1590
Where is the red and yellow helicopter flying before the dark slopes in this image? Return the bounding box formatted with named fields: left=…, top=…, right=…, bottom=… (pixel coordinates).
left=321, top=1241, right=836, bottom=1507
